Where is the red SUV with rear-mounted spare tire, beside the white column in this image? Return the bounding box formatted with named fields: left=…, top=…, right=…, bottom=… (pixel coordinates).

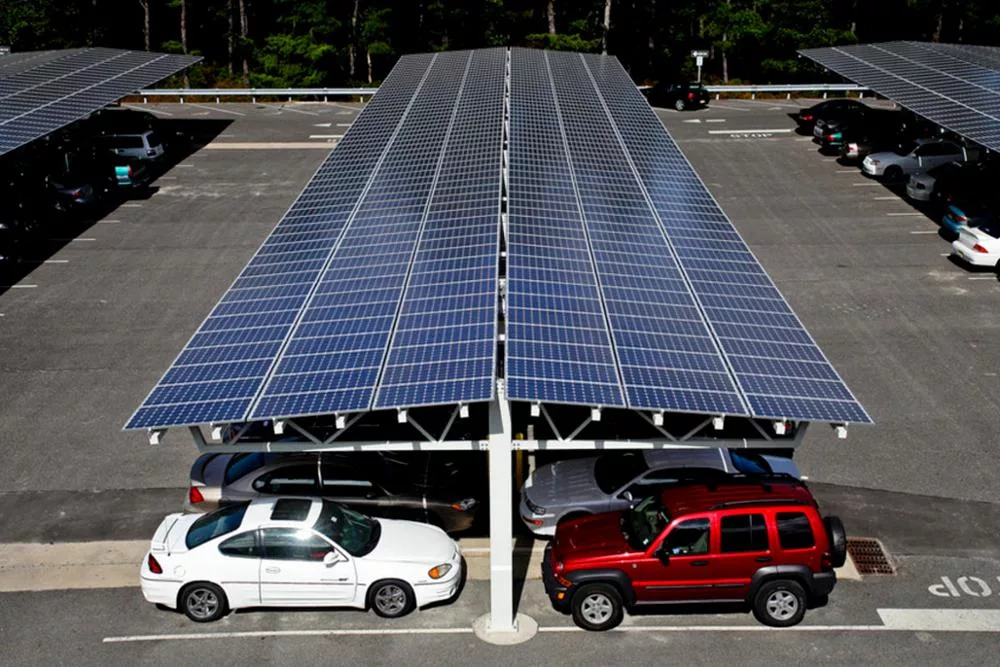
left=542, top=478, right=847, bottom=630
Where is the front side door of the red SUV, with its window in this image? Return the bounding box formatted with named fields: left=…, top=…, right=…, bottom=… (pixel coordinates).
left=629, top=515, right=714, bottom=603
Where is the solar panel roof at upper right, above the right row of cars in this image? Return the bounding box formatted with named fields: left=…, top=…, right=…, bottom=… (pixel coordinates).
left=800, top=42, right=1000, bottom=150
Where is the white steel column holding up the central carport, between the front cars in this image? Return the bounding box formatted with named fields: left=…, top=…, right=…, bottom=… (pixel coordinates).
left=487, top=381, right=517, bottom=632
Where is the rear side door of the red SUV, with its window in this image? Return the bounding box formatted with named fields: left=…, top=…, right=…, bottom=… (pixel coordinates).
left=712, top=510, right=774, bottom=600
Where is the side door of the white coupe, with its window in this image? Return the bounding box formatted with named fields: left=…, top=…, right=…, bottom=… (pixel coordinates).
left=260, top=526, right=357, bottom=606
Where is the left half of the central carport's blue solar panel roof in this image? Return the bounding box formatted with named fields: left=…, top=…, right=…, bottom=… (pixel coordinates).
left=127, top=49, right=504, bottom=428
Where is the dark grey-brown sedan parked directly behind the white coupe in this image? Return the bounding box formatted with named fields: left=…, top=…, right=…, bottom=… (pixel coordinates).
left=185, top=453, right=480, bottom=533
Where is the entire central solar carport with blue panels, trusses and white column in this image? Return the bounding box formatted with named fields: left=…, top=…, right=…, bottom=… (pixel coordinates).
left=126, top=48, right=870, bottom=632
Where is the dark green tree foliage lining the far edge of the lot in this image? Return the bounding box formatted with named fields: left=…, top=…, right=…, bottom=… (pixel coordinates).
left=0, top=0, right=1000, bottom=86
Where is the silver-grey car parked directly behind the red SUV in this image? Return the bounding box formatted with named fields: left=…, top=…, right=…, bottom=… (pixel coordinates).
left=519, top=448, right=799, bottom=537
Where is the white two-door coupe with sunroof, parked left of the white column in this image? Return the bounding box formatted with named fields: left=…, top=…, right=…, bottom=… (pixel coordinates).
left=140, top=498, right=462, bottom=623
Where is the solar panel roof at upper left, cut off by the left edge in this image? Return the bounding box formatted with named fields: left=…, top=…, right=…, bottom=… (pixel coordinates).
left=0, top=48, right=201, bottom=155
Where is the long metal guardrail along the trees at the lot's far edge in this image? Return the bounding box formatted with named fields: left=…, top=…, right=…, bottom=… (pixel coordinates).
left=136, top=83, right=870, bottom=104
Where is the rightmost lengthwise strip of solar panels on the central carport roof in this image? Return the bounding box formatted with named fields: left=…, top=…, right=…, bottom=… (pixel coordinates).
left=582, top=56, right=870, bottom=423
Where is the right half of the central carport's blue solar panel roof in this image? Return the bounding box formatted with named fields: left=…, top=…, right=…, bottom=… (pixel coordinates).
left=507, top=49, right=868, bottom=422
